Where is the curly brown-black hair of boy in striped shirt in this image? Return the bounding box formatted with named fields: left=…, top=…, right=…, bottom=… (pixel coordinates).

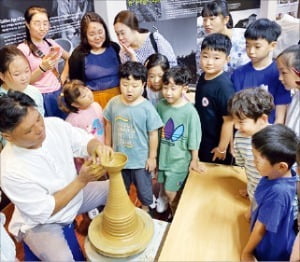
left=227, top=87, right=275, bottom=121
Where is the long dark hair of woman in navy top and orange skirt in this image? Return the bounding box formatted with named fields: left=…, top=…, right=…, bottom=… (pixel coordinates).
left=80, top=12, right=110, bottom=53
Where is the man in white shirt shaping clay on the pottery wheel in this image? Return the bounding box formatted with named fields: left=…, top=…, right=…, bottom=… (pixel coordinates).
left=0, top=91, right=112, bottom=261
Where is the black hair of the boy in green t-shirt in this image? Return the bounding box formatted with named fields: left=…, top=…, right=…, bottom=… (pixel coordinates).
left=162, top=66, right=192, bottom=85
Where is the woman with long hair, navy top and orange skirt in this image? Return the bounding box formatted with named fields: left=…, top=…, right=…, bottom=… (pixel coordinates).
left=69, top=12, right=120, bottom=108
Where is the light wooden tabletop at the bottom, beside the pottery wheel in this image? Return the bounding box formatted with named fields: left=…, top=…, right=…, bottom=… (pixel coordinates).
left=159, top=164, right=249, bottom=261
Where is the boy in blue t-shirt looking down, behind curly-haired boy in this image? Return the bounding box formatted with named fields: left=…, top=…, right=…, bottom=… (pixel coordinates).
left=231, top=18, right=291, bottom=124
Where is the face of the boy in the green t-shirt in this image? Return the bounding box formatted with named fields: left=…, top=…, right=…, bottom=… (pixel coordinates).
left=162, top=78, right=187, bottom=105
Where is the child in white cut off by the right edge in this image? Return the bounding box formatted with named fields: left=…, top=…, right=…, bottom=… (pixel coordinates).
left=276, top=45, right=300, bottom=136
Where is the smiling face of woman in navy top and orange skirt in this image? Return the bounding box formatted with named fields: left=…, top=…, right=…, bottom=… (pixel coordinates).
left=86, top=22, right=106, bottom=51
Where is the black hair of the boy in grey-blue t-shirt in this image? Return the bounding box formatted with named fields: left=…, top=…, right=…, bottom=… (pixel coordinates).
left=119, top=61, right=147, bottom=83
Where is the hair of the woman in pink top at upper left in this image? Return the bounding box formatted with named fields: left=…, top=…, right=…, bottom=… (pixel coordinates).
left=24, top=6, right=51, bottom=57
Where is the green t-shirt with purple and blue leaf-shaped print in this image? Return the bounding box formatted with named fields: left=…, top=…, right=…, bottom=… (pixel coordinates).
left=157, top=99, right=201, bottom=172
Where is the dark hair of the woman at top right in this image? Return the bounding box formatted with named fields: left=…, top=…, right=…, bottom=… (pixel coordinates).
left=201, top=0, right=233, bottom=29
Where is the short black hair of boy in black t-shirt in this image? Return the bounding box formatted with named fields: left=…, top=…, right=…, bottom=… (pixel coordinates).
left=201, top=33, right=232, bottom=55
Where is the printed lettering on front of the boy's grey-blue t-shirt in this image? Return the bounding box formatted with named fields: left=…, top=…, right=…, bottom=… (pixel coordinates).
left=115, top=116, right=136, bottom=148
